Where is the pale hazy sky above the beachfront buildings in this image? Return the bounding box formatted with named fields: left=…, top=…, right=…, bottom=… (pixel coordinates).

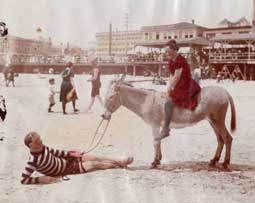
left=0, top=0, right=253, bottom=47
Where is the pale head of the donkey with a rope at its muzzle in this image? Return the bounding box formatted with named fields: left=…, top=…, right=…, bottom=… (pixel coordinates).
left=102, top=74, right=126, bottom=120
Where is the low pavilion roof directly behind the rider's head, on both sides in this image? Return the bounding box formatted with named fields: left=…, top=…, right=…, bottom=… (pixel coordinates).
left=136, top=37, right=209, bottom=48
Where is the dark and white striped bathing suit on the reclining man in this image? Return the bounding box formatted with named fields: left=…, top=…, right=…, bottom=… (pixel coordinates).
left=21, top=146, right=85, bottom=184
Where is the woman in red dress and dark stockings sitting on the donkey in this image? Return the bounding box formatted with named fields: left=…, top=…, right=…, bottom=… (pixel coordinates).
left=159, top=40, right=201, bottom=140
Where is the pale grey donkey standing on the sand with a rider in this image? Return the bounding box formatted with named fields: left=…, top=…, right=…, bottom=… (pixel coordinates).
left=102, top=75, right=236, bottom=170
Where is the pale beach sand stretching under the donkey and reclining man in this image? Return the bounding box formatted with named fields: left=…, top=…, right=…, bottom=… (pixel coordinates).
left=0, top=74, right=255, bottom=203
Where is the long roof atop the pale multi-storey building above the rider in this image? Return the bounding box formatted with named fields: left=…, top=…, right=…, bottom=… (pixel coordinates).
left=141, top=22, right=206, bottom=32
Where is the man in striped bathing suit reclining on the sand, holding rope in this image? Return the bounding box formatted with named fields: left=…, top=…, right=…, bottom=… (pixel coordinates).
left=21, top=132, right=133, bottom=184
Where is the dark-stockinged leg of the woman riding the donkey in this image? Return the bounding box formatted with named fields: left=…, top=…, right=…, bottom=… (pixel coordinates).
left=159, top=97, right=173, bottom=140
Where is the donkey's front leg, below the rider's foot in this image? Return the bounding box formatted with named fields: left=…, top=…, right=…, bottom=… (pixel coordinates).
left=151, top=126, right=162, bottom=168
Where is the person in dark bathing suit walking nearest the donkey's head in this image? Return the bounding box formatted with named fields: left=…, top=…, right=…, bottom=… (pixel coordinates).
left=85, top=60, right=104, bottom=112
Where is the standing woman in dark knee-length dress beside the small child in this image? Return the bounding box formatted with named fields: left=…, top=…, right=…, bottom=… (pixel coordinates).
left=60, top=62, right=79, bottom=114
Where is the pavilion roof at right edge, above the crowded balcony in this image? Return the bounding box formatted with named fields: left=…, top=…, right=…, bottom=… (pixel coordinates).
left=211, top=33, right=255, bottom=44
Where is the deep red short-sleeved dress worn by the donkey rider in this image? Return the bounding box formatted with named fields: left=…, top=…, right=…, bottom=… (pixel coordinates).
left=168, top=55, right=201, bottom=110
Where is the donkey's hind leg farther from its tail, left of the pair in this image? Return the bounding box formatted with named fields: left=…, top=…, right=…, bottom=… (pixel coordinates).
left=209, top=121, right=224, bottom=166
